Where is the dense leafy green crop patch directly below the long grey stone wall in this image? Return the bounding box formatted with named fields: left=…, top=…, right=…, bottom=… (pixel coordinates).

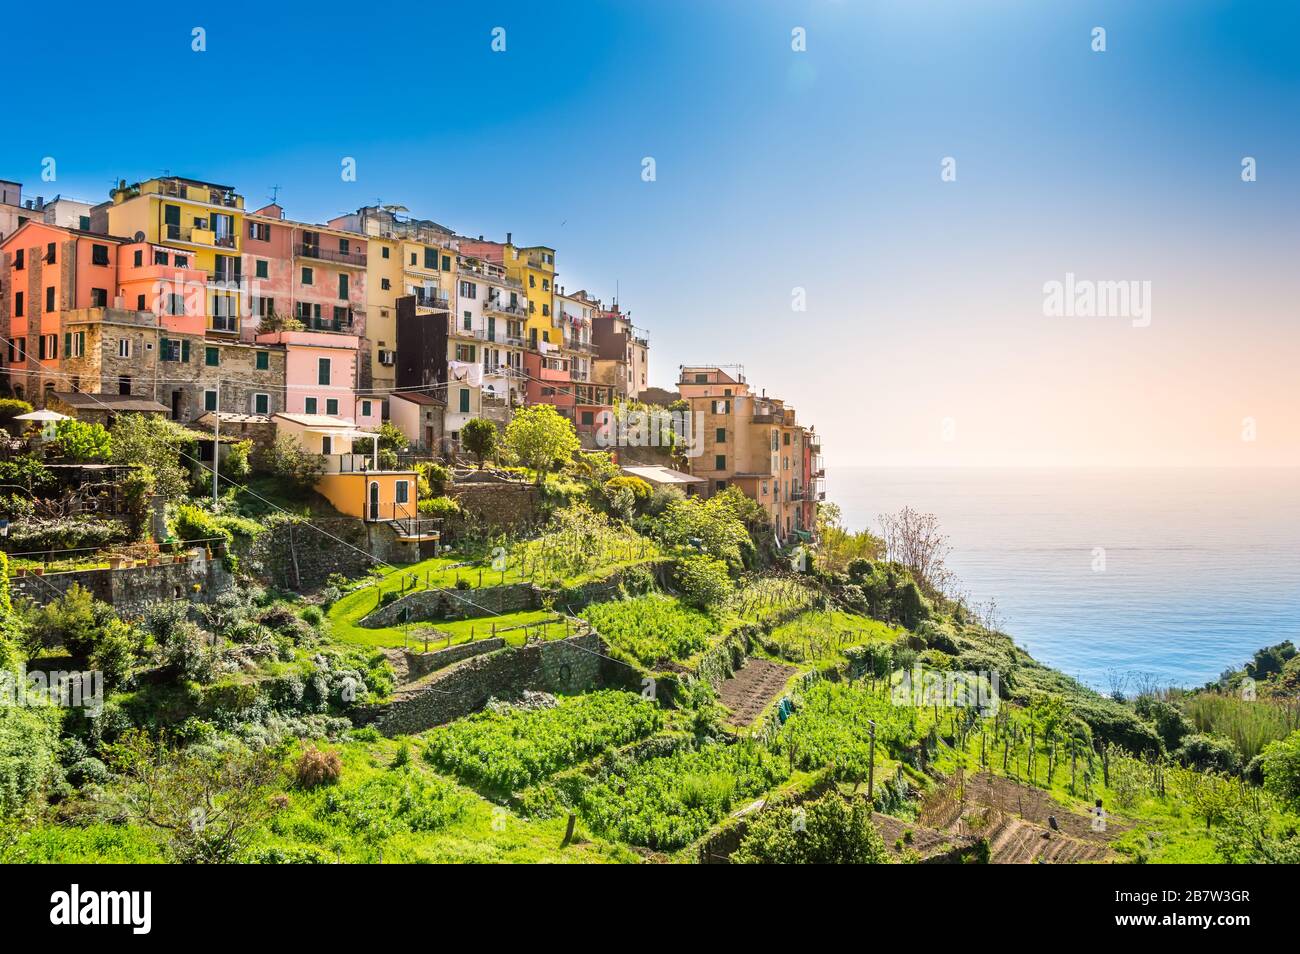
left=424, top=690, right=663, bottom=794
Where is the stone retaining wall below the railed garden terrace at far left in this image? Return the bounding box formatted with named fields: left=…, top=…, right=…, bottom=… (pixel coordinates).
left=9, top=551, right=234, bottom=616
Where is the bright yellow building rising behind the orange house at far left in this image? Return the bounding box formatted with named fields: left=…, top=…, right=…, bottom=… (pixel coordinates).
left=91, top=175, right=244, bottom=335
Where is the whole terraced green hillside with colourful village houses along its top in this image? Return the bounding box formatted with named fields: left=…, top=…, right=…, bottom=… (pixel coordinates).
left=0, top=177, right=1300, bottom=863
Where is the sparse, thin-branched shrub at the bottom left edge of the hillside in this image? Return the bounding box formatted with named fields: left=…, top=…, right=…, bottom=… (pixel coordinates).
left=108, top=729, right=285, bottom=864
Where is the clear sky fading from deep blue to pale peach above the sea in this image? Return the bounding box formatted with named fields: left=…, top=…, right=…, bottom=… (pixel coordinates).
left=0, top=0, right=1300, bottom=465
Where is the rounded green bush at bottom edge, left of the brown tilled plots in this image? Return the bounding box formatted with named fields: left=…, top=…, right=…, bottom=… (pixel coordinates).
left=731, top=792, right=889, bottom=864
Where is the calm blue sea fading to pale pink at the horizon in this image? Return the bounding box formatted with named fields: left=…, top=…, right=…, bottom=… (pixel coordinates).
left=827, top=468, right=1300, bottom=690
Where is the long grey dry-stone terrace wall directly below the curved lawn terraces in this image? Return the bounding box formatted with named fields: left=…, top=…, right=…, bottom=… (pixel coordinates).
left=354, top=633, right=607, bottom=736
